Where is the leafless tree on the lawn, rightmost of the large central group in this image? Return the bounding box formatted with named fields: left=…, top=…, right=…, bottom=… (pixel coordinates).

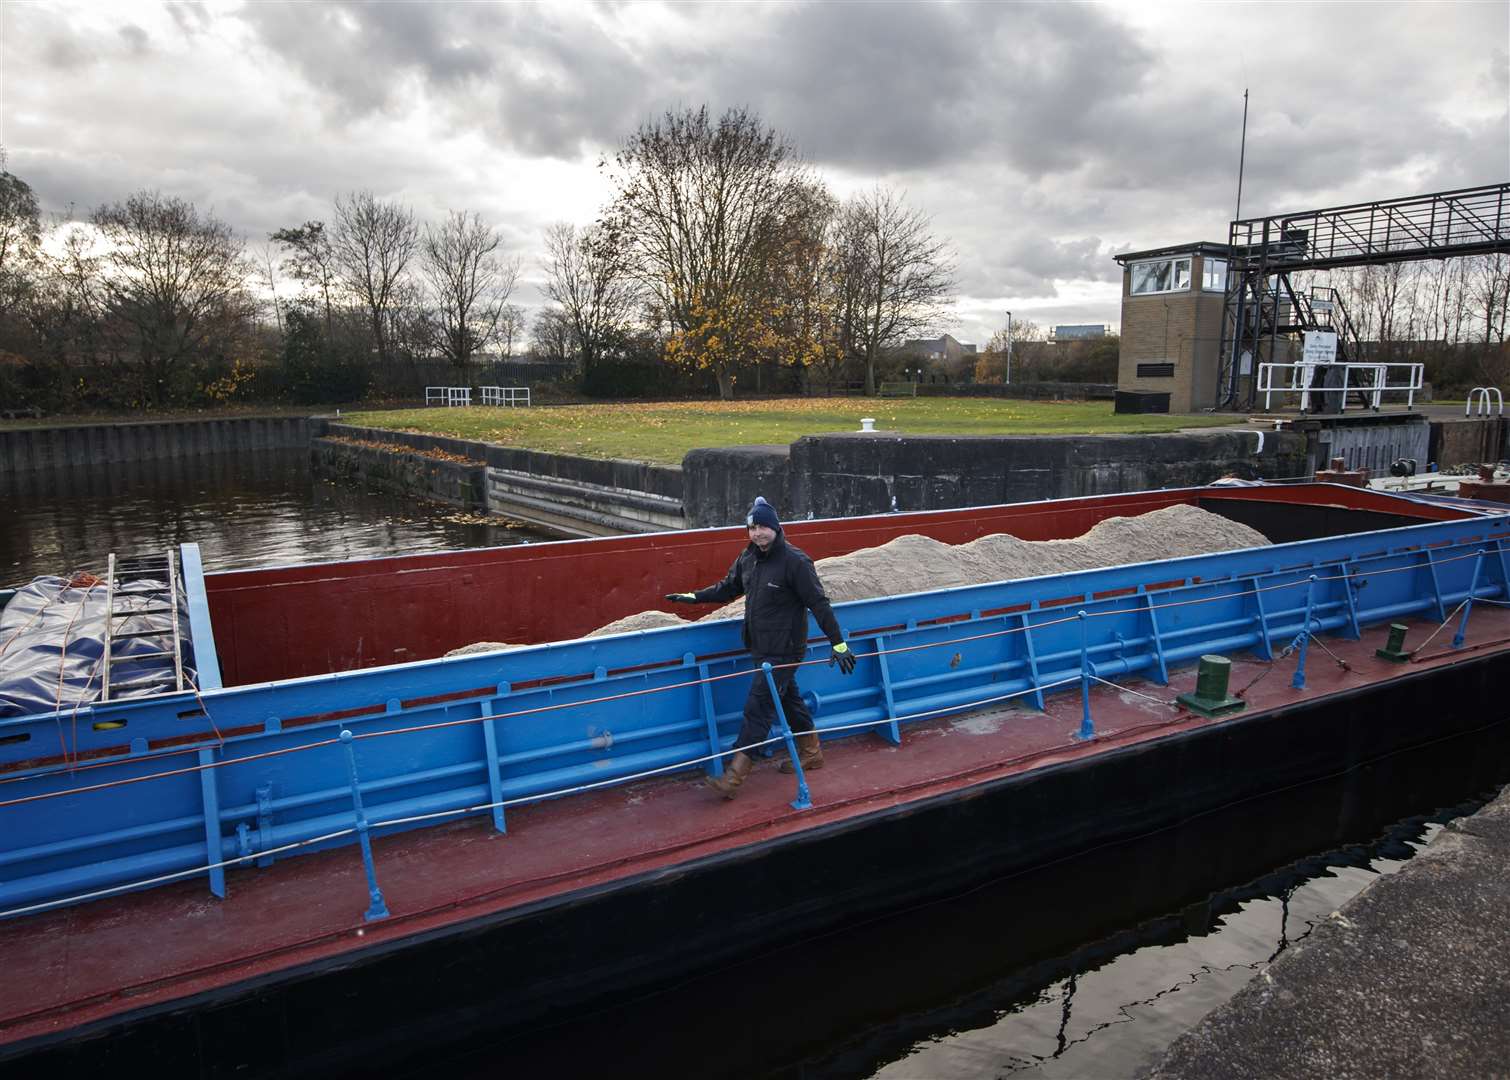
left=840, top=187, right=954, bottom=394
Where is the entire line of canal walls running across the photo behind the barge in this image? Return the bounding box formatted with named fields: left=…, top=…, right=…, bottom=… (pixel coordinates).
left=0, top=415, right=1507, bottom=536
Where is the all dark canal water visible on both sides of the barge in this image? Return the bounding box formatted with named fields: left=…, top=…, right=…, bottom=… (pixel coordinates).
left=0, top=450, right=1505, bottom=1080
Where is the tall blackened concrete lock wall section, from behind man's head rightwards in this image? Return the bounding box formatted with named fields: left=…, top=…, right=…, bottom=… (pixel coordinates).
left=683, top=430, right=1308, bottom=526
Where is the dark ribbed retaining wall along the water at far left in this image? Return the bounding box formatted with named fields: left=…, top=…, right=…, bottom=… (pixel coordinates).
left=0, top=417, right=325, bottom=473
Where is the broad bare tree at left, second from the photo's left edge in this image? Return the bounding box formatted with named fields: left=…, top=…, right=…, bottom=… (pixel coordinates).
left=92, top=192, right=255, bottom=403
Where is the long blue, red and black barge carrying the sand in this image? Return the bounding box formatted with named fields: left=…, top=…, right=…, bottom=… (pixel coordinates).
left=0, top=483, right=1510, bottom=1075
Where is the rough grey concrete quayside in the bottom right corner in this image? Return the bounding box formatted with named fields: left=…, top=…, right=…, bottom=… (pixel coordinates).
left=1143, top=788, right=1510, bottom=1080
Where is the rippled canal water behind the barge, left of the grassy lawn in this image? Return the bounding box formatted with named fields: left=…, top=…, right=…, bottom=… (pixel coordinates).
left=0, top=450, right=542, bottom=588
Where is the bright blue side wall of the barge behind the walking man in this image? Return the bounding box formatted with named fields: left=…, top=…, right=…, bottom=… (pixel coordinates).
left=0, top=515, right=1510, bottom=915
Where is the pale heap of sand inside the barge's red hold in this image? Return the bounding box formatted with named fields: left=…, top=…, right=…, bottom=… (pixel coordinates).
left=445, top=503, right=1268, bottom=656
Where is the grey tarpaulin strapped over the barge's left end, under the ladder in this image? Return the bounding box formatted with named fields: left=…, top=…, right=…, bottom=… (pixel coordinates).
left=0, top=575, right=193, bottom=717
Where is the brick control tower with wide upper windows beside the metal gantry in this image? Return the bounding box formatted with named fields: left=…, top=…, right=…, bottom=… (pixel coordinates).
left=1116, top=243, right=1229, bottom=412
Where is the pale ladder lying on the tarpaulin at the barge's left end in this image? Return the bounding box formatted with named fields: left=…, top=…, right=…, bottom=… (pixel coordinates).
left=100, top=548, right=184, bottom=701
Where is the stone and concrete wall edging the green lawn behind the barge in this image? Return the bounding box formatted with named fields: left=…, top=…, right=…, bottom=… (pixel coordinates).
left=311, top=423, right=1306, bottom=536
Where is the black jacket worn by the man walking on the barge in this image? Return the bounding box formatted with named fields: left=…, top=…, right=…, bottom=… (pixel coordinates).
left=693, top=529, right=844, bottom=657
